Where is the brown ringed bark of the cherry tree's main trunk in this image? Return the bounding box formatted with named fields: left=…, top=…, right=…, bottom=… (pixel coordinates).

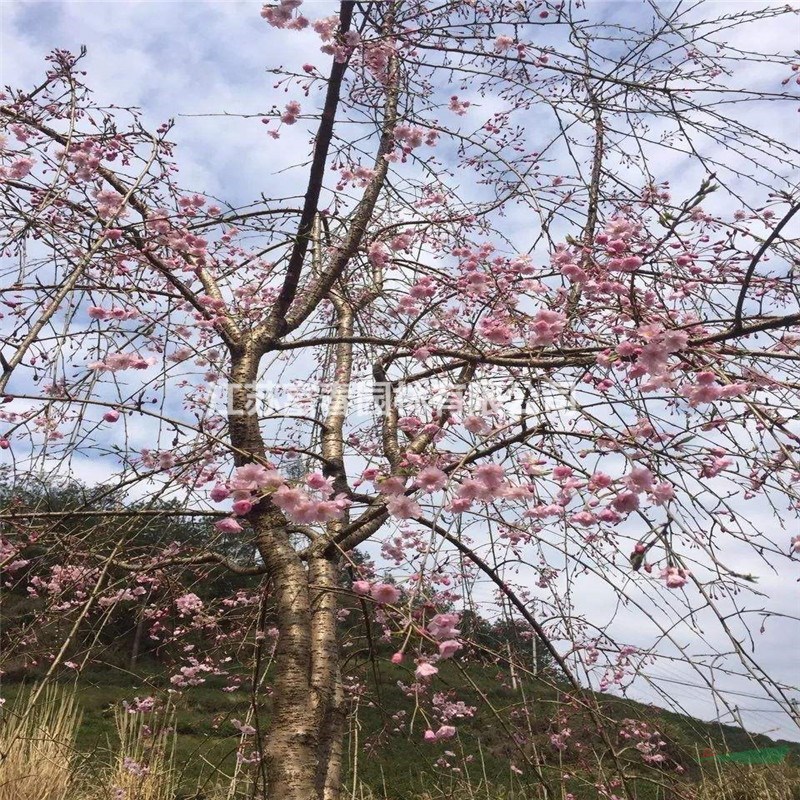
left=229, top=347, right=344, bottom=800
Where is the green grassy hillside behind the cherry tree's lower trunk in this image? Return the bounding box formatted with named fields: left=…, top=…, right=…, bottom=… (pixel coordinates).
left=0, top=662, right=800, bottom=800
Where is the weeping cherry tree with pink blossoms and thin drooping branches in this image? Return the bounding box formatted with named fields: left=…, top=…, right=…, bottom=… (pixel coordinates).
left=0, top=0, right=800, bottom=800
